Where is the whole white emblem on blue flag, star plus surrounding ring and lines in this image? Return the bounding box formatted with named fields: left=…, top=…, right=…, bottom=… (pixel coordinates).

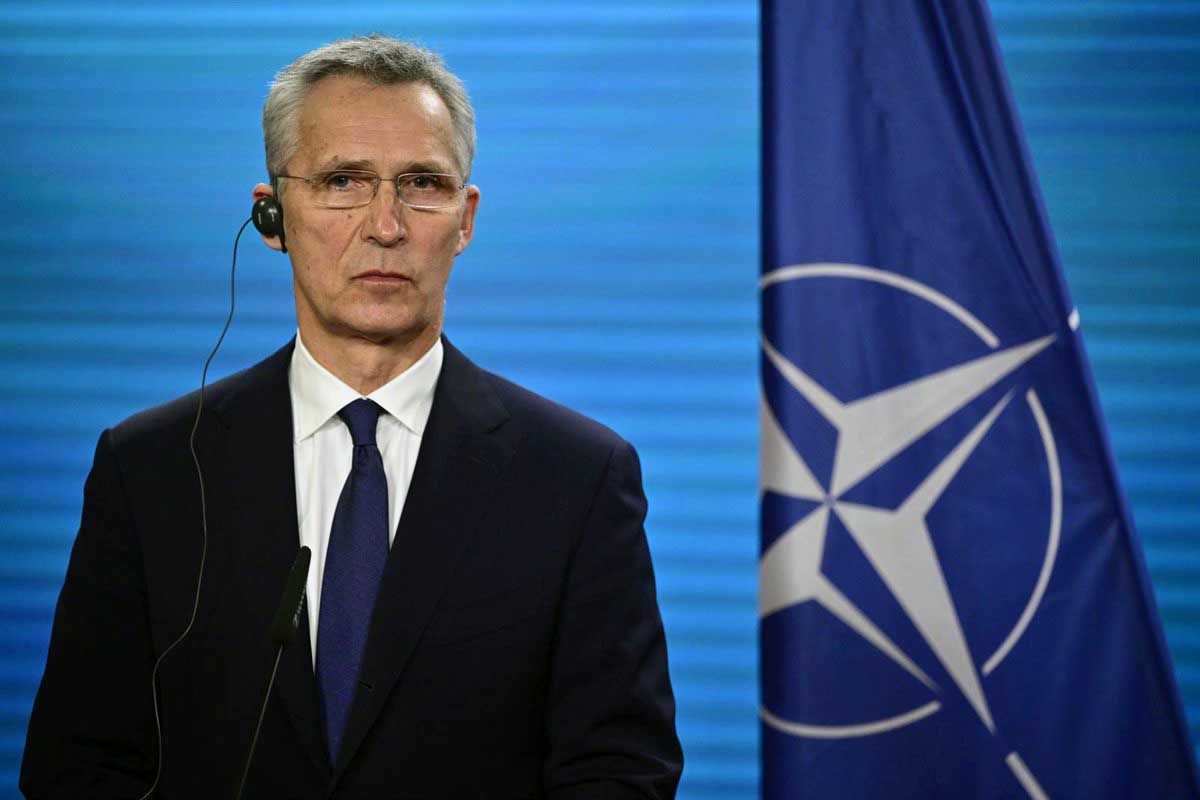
left=758, top=264, right=1062, bottom=800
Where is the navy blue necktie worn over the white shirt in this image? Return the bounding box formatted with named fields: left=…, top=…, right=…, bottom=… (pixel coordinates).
left=317, top=399, right=388, bottom=764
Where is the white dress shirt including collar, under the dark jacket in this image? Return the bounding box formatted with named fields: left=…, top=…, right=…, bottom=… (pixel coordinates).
left=288, top=332, right=443, bottom=664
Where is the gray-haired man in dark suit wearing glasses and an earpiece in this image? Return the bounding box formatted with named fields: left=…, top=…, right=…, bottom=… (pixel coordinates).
left=22, top=36, right=682, bottom=798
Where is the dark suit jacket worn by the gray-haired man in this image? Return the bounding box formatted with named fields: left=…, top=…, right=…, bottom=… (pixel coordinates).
left=20, top=342, right=683, bottom=800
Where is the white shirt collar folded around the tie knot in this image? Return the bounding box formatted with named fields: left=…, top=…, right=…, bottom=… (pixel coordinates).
left=288, top=331, right=444, bottom=441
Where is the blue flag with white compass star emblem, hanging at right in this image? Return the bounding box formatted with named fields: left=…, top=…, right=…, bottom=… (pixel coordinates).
left=760, top=0, right=1198, bottom=800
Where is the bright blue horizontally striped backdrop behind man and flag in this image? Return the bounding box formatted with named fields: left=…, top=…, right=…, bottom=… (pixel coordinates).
left=0, top=0, right=1200, bottom=799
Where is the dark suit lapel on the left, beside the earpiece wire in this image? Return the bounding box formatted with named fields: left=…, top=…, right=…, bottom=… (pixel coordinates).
left=217, top=344, right=329, bottom=771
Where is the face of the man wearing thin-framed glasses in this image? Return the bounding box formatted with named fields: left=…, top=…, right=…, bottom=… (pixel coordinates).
left=256, top=77, right=479, bottom=347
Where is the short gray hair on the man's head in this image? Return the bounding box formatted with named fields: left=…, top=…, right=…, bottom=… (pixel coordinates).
left=263, top=34, right=475, bottom=184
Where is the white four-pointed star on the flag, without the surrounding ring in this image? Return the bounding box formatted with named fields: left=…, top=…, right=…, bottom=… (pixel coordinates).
left=758, top=328, right=1054, bottom=730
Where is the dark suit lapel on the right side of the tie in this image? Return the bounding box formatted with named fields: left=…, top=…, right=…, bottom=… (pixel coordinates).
left=331, top=339, right=512, bottom=781
